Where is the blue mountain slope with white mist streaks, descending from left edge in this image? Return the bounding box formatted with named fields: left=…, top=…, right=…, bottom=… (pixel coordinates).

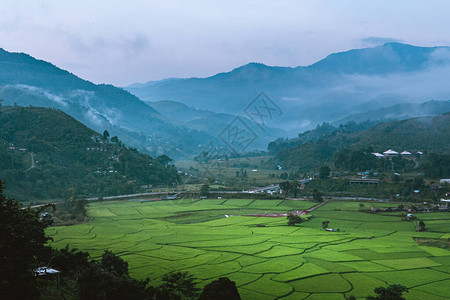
left=0, top=49, right=213, bottom=155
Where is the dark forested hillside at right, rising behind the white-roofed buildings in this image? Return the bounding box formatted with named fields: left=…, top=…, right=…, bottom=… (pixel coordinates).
left=269, top=113, right=450, bottom=171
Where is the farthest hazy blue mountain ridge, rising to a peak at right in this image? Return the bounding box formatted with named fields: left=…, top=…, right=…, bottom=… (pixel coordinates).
left=126, top=43, right=450, bottom=133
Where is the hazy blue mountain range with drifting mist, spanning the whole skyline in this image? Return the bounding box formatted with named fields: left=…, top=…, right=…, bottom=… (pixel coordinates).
left=0, top=43, right=450, bottom=158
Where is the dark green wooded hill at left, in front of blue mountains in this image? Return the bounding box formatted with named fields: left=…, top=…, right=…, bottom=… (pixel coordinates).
left=0, top=107, right=177, bottom=201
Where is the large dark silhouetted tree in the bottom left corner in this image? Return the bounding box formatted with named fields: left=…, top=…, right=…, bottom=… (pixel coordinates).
left=0, top=181, right=49, bottom=299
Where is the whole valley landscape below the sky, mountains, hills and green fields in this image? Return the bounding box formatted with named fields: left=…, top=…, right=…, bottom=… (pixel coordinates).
left=0, top=34, right=450, bottom=300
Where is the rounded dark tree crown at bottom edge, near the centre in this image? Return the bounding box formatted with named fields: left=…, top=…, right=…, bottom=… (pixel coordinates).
left=199, top=277, right=241, bottom=300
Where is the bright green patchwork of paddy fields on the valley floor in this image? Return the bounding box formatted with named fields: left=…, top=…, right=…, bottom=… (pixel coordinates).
left=47, top=199, right=450, bottom=299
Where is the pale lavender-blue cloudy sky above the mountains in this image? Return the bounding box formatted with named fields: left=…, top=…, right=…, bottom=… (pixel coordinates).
left=0, top=0, right=450, bottom=86
